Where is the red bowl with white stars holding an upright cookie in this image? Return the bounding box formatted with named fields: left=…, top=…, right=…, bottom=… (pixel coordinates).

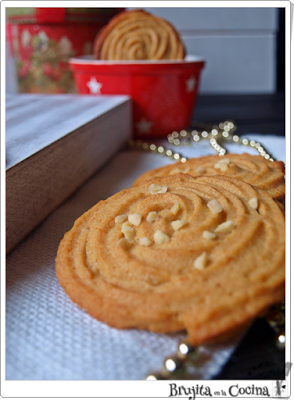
left=69, top=56, right=205, bottom=138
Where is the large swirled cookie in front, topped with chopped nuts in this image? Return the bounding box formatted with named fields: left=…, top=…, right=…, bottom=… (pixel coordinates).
left=56, top=174, right=285, bottom=345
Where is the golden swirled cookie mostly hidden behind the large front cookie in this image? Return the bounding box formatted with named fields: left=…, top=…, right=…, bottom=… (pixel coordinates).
left=132, top=153, right=285, bottom=201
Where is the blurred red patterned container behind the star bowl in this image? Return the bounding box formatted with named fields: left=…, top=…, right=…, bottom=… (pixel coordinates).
left=6, top=7, right=124, bottom=93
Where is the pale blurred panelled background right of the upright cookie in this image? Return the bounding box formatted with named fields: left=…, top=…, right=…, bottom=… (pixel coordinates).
left=138, top=6, right=278, bottom=94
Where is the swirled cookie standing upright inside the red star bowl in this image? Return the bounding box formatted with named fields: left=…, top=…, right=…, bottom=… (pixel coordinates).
left=94, top=10, right=185, bottom=60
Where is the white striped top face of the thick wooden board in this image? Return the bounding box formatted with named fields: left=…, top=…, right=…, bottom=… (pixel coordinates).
left=6, top=94, right=128, bottom=169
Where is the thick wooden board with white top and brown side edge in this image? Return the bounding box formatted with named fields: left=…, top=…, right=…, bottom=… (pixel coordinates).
left=6, top=94, right=132, bottom=251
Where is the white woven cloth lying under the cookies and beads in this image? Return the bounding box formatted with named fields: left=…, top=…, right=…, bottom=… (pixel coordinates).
left=6, top=135, right=285, bottom=380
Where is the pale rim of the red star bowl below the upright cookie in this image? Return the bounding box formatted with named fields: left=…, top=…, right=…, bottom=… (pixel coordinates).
left=69, top=54, right=205, bottom=65
